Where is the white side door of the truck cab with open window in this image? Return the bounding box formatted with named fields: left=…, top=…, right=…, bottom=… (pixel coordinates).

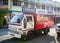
left=24, top=16, right=34, bottom=29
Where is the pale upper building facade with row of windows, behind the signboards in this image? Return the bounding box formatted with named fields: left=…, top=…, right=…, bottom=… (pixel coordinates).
left=24, top=0, right=60, bottom=23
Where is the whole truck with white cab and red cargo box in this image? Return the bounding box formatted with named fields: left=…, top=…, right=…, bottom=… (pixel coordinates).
left=8, top=8, right=54, bottom=39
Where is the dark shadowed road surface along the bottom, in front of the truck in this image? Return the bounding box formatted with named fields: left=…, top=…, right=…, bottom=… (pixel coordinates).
left=0, top=35, right=56, bottom=43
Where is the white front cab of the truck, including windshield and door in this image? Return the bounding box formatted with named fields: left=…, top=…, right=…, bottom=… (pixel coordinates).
left=8, top=14, right=34, bottom=38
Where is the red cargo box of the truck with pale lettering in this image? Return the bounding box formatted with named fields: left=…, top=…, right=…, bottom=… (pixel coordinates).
left=32, top=14, right=54, bottom=30
